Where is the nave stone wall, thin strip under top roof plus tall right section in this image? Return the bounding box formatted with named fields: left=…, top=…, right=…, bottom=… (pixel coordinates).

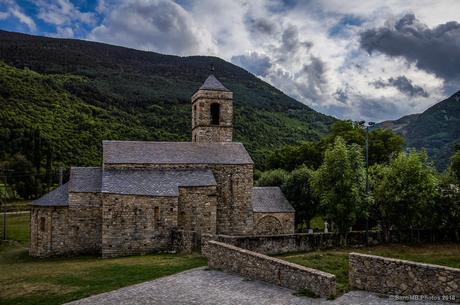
left=104, top=164, right=254, bottom=235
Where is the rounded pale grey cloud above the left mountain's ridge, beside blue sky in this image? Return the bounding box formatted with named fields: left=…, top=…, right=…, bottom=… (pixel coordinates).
left=89, top=0, right=215, bottom=55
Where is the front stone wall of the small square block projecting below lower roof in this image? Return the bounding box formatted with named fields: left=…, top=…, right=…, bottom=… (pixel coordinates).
left=178, top=186, right=217, bottom=234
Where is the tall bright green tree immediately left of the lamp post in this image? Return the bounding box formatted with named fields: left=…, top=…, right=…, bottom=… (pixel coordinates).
left=311, top=137, right=365, bottom=242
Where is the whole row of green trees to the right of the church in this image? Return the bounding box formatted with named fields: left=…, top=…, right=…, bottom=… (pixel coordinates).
left=257, top=122, right=460, bottom=237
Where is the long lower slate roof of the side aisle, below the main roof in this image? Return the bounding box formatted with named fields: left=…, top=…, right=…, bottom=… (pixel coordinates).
left=102, top=169, right=216, bottom=196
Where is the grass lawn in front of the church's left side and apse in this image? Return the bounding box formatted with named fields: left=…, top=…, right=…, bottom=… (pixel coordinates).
left=0, top=214, right=206, bottom=305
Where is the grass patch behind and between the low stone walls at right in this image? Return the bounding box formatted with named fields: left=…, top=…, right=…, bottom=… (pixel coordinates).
left=279, top=244, right=460, bottom=294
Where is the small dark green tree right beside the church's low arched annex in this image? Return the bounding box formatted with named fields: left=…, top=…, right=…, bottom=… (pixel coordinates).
left=282, top=166, right=318, bottom=229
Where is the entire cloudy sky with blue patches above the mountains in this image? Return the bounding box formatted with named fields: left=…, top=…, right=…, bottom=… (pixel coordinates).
left=0, top=0, right=460, bottom=121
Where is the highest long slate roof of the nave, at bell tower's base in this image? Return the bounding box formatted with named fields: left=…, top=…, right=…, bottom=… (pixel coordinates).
left=102, top=141, right=253, bottom=164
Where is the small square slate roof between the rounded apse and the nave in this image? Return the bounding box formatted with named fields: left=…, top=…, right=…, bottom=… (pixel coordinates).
left=69, top=167, right=102, bottom=193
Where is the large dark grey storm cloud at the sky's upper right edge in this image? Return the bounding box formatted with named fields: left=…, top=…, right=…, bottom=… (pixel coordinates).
left=360, top=14, right=460, bottom=80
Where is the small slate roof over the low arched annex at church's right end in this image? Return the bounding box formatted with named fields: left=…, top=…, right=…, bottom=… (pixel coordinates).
left=252, top=187, right=295, bottom=213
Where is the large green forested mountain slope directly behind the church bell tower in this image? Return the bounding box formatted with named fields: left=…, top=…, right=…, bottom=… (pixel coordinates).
left=0, top=31, right=335, bottom=167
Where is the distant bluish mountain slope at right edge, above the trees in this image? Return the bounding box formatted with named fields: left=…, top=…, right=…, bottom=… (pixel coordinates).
left=378, top=91, right=460, bottom=169
